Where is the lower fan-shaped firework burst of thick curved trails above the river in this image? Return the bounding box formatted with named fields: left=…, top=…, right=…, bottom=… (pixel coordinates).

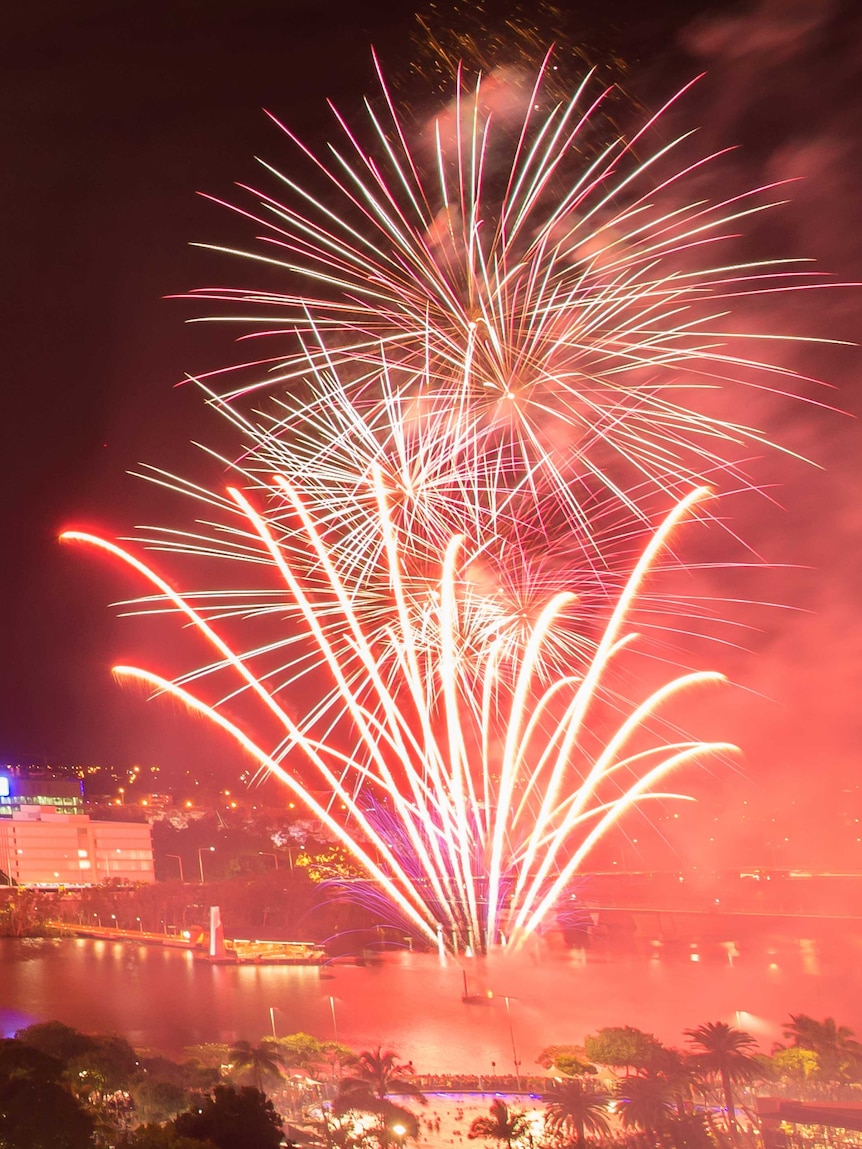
left=63, top=472, right=733, bottom=950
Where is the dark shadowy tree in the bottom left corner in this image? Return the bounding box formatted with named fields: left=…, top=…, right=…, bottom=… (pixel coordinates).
left=0, top=1077, right=94, bottom=1149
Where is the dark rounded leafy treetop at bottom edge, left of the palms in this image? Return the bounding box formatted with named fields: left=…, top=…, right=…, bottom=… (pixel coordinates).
left=174, top=1085, right=282, bottom=1149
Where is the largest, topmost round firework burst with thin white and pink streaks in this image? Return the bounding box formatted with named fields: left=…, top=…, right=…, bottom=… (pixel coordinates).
left=186, top=60, right=827, bottom=530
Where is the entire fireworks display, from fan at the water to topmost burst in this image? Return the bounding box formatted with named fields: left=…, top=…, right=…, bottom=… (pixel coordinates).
left=69, top=60, right=822, bottom=949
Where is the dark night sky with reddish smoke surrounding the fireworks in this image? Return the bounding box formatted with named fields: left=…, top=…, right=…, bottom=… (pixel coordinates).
left=0, top=0, right=862, bottom=869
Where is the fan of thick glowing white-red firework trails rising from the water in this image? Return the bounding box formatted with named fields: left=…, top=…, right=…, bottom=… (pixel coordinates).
left=64, top=478, right=729, bottom=948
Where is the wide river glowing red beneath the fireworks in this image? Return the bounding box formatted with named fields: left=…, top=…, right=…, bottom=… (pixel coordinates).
left=0, top=931, right=862, bottom=1073
